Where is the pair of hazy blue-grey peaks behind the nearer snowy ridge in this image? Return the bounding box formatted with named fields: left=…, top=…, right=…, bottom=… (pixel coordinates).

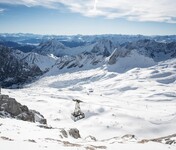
left=34, top=39, right=116, bottom=57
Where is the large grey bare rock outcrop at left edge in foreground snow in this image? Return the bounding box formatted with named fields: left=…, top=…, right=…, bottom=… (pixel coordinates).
left=0, top=95, right=47, bottom=124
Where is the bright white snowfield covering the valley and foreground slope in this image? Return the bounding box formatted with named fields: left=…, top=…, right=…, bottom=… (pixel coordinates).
left=0, top=56, right=176, bottom=150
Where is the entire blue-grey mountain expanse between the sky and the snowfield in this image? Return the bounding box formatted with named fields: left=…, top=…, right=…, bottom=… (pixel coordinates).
left=0, top=34, right=176, bottom=87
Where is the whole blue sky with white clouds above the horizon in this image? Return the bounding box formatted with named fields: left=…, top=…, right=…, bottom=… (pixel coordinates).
left=0, top=0, right=176, bottom=35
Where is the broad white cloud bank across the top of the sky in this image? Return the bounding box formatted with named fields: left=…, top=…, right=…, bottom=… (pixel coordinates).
left=0, top=0, right=176, bottom=23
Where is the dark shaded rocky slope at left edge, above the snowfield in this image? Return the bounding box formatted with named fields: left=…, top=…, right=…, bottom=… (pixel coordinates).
left=0, top=46, right=42, bottom=87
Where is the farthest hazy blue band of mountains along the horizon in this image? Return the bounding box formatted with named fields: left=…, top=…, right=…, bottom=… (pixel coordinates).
left=0, top=33, right=176, bottom=47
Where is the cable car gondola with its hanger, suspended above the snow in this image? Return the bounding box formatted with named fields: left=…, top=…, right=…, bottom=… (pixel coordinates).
left=71, top=99, right=85, bottom=121
